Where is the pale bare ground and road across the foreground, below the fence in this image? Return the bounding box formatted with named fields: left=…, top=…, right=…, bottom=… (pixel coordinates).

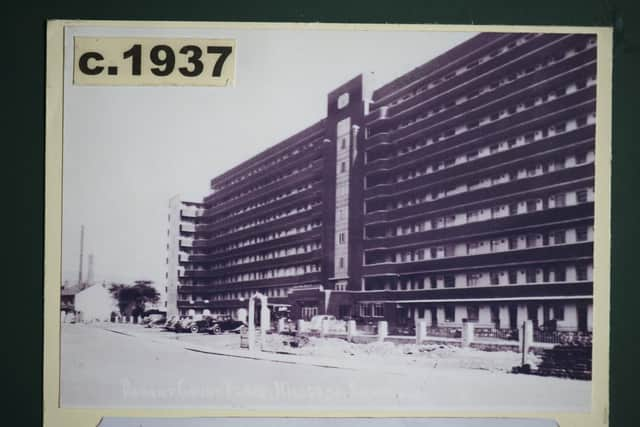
left=61, top=325, right=591, bottom=412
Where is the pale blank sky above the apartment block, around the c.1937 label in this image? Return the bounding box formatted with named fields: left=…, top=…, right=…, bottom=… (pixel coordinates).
left=62, top=24, right=475, bottom=287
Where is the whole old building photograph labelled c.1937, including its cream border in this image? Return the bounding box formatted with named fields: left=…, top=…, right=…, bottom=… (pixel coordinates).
left=44, top=21, right=612, bottom=426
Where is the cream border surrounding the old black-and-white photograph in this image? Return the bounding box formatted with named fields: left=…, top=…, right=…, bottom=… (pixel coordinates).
left=43, top=20, right=613, bottom=427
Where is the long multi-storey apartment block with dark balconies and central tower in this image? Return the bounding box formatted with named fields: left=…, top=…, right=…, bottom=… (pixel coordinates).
left=169, top=33, right=596, bottom=331
